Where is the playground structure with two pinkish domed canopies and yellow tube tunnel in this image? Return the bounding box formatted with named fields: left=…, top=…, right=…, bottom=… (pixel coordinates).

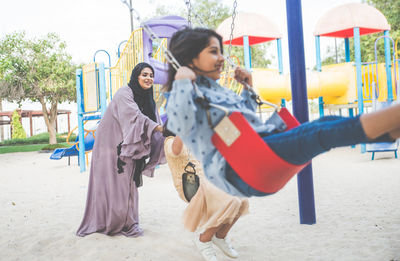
left=217, top=3, right=400, bottom=116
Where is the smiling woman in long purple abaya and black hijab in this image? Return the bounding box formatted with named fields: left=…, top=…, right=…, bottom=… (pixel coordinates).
left=77, top=63, right=165, bottom=237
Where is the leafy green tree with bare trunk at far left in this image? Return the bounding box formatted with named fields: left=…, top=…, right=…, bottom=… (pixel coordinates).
left=0, top=32, right=77, bottom=144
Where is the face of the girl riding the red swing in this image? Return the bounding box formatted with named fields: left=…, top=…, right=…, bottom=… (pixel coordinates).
left=191, top=37, right=224, bottom=80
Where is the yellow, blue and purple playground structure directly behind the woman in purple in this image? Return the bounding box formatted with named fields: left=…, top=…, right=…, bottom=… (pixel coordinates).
left=50, top=16, right=187, bottom=172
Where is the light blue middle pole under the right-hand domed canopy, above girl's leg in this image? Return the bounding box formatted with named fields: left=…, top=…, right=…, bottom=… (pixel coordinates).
left=353, top=27, right=365, bottom=153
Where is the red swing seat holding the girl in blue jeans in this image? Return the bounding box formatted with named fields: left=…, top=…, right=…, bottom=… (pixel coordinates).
left=211, top=108, right=308, bottom=193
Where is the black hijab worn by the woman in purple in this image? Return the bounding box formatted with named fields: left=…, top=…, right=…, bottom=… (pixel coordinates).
left=128, top=63, right=157, bottom=122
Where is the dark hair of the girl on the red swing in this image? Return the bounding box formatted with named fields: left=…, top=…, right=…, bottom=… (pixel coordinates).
left=164, top=28, right=223, bottom=92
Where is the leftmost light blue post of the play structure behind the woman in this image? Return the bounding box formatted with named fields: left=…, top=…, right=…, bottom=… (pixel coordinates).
left=76, top=69, right=86, bottom=172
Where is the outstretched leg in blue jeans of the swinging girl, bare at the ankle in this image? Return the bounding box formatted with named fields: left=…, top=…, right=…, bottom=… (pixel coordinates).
left=263, top=109, right=400, bottom=165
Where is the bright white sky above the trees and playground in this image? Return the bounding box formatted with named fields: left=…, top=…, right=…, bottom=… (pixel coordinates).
left=0, top=0, right=360, bottom=69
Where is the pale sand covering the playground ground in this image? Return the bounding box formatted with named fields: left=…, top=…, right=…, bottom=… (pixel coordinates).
left=0, top=148, right=400, bottom=261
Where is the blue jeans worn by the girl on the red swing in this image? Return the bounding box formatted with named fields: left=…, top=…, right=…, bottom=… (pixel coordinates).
left=226, top=116, right=394, bottom=197
